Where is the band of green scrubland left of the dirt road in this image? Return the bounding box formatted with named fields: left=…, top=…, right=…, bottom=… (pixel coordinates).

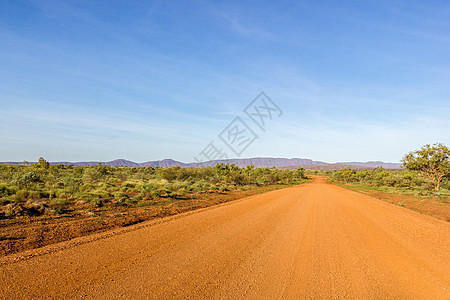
left=0, top=158, right=306, bottom=218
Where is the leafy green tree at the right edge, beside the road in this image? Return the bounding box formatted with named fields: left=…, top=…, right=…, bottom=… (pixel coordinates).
left=402, top=143, right=450, bottom=191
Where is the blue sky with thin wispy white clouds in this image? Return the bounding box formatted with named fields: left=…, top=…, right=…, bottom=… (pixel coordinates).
left=0, top=0, right=450, bottom=162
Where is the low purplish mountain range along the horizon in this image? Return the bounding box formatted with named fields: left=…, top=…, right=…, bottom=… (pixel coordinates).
left=0, top=157, right=401, bottom=170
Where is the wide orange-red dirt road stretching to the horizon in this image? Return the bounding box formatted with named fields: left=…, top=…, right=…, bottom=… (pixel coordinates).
left=0, top=178, right=450, bottom=299
